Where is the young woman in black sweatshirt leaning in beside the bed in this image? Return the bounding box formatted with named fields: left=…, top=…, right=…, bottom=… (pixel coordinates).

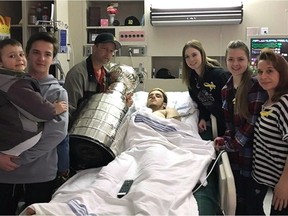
left=182, top=40, right=230, bottom=139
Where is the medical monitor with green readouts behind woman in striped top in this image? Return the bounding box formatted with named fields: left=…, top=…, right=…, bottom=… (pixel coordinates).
left=248, top=35, right=288, bottom=66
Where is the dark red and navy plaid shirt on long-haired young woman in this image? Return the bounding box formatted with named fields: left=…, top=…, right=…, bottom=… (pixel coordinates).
left=222, top=77, right=267, bottom=177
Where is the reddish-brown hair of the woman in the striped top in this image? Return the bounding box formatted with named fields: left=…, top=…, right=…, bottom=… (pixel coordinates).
left=256, top=48, right=288, bottom=102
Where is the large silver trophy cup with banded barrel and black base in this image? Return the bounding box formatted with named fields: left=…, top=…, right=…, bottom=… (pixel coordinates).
left=69, top=64, right=139, bottom=170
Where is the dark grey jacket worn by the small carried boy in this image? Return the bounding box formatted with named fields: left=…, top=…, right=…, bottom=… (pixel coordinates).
left=0, top=68, right=56, bottom=153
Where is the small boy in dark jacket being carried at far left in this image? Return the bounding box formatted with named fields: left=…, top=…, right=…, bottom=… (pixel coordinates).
left=0, top=39, right=67, bottom=156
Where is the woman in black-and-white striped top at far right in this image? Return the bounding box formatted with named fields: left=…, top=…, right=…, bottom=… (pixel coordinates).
left=251, top=49, right=288, bottom=215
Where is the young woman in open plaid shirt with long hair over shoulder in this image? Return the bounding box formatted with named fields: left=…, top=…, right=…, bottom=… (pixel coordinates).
left=215, top=40, right=267, bottom=215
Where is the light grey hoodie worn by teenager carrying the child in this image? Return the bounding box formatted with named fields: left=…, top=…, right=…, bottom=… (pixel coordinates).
left=0, top=75, right=68, bottom=184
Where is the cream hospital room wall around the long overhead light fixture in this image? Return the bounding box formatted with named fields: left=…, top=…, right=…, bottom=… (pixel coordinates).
left=69, top=0, right=288, bottom=91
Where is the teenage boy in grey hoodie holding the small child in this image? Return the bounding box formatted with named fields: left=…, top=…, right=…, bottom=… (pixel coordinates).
left=0, top=32, right=68, bottom=215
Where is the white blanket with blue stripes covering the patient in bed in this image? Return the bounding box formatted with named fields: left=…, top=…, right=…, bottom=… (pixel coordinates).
left=22, top=111, right=214, bottom=215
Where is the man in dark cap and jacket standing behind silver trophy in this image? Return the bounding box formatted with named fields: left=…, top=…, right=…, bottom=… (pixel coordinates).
left=64, top=33, right=121, bottom=128
